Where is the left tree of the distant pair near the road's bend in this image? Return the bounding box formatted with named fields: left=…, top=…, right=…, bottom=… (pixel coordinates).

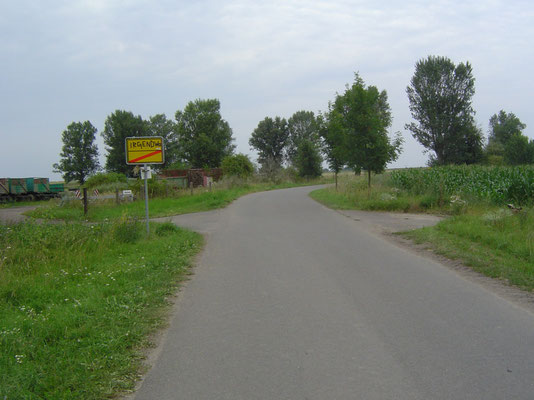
left=248, top=117, right=289, bottom=169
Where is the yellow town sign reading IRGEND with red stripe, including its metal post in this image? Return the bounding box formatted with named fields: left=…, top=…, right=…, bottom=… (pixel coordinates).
left=124, top=136, right=165, bottom=235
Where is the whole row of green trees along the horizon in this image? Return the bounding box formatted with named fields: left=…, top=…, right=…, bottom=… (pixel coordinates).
left=54, top=56, right=534, bottom=185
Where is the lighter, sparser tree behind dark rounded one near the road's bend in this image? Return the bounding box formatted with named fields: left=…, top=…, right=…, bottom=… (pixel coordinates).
left=286, top=111, right=319, bottom=165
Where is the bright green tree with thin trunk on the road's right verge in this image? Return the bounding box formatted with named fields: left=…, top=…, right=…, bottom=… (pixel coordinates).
left=330, top=74, right=402, bottom=187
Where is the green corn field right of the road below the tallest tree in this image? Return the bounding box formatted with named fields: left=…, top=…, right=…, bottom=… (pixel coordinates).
left=391, top=165, right=534, bottom=205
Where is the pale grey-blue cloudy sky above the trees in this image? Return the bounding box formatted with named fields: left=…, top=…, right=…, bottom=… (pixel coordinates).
left=0, top=0, right=534, bottom=179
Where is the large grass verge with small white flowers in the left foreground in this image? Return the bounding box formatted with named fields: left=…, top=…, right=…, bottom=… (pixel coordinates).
left=0, top=218, right=202, bottom=399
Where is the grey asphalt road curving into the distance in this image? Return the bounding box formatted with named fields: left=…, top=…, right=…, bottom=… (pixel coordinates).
left=134, top=188, right=534, bottom=400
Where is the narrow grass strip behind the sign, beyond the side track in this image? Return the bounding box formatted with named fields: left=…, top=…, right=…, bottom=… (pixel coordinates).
left=27, top=179, right=330, bottom=221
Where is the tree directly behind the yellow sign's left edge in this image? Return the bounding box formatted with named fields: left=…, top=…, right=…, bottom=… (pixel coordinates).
left=102, top=110, right=149, bottom=176
